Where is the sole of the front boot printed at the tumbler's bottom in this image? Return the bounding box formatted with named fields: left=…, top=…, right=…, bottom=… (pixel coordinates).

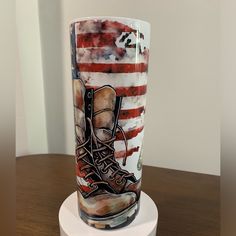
left=80, top=201, right=139, bottom=230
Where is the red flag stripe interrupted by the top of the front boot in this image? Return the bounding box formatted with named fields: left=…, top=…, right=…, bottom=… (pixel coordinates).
left=86, top=85, right=147, bottom=97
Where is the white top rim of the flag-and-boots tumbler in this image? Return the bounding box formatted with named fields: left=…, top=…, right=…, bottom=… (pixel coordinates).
left=70, top=16, right=150, bottom=27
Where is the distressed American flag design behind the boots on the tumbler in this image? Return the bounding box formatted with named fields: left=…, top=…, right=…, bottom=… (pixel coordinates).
left=70, top=18, right=149, bottom=224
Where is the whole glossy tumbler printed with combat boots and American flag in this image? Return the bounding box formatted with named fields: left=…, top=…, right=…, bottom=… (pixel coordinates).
left=70, top=17, right=150, bottom=229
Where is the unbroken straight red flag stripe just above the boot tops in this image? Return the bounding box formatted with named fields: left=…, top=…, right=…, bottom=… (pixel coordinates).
left=77, top=63, right=148, bottom=73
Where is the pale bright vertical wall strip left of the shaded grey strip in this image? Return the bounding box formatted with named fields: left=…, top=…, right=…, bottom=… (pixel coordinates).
left=16, top=0, right=48, bottom=154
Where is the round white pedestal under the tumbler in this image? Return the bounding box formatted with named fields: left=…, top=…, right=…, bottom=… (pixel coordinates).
left=59, top=192, right=158, bottom=236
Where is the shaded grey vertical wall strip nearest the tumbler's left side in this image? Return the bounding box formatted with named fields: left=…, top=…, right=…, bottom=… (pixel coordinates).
left=38, top=0, right=66, bottom=153
